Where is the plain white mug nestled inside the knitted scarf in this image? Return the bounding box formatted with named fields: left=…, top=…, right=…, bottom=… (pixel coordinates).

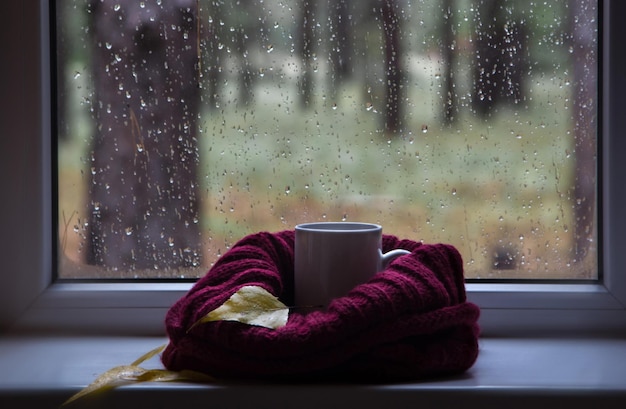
left=294, top=222, right=410, bottom=307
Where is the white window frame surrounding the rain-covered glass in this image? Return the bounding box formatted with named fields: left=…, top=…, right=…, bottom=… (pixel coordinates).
left=0, top=0, right=626, bottom=336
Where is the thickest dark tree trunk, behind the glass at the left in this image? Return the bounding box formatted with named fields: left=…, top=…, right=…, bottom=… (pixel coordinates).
left=88, top=0, right=201, bottom=270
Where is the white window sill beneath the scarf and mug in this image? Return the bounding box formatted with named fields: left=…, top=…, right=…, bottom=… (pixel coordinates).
left=0, top=335, right=626, bottom=409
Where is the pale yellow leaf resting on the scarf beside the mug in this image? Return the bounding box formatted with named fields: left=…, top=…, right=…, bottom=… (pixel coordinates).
left=190, top=285, right=289, bottom=330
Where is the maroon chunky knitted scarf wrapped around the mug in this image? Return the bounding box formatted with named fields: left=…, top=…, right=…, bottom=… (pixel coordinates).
left=162, top=230, right=479, bottom=381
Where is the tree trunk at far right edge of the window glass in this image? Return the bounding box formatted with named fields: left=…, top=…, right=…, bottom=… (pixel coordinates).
left=569, top=0, right=598, bottom=261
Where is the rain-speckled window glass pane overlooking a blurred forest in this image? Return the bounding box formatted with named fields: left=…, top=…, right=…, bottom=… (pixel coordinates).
left=56, top=0, right=599, bottom=280
